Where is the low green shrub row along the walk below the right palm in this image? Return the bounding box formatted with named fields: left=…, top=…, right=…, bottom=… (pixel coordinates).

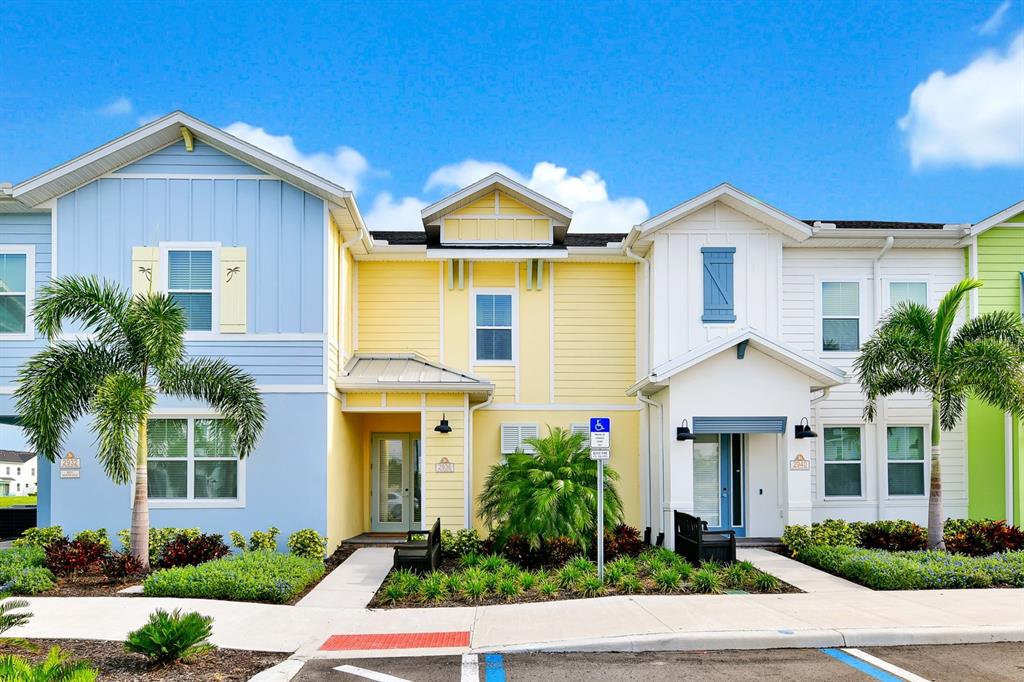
left=797, top=545, right=1024, bottom=590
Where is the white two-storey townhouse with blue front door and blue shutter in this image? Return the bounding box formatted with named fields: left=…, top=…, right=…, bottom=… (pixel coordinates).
left=624, top=184, right=967, bottom=546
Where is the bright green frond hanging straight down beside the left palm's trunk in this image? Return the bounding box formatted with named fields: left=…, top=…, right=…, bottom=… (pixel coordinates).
left=91, top=372, right=157, bottom=484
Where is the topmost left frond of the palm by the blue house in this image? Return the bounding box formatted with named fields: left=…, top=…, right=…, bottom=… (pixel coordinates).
left=33, top=275, right=131, bottom=344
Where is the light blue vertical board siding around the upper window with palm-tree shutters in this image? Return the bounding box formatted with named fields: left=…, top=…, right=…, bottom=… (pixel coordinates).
left=56, top=177, right=327, bottom=334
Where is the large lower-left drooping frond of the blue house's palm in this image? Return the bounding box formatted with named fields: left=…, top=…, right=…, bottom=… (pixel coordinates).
left=14, top=341, right=127, bottom=462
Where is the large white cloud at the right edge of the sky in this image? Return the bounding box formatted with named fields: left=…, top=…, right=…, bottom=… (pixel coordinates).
left=898, top=32, right=1024, bottom=168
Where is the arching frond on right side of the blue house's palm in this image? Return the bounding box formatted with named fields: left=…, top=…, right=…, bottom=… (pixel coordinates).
left=159, top=357, right=266, bottom=457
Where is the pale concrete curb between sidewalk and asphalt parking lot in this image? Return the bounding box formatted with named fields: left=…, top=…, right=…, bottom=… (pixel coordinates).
left=472, top=626, right=1024, bottom=653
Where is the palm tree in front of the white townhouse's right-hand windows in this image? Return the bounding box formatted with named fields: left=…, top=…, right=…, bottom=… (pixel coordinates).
left=855, top=279, right=1024, bottom=549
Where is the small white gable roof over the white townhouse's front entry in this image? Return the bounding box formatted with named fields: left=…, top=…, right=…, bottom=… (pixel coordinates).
left=627, top=327, right=847, bottom=395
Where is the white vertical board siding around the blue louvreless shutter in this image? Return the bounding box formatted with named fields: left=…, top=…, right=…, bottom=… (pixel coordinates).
left=647, top=202, right=784, bottom=367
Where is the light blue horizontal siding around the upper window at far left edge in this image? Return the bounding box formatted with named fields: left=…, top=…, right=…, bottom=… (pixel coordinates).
left=0, top=213, right=52, bottom=387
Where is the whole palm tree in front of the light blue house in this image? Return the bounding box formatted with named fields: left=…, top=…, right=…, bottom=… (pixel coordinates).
left=15, top=276, right=265, bottom=568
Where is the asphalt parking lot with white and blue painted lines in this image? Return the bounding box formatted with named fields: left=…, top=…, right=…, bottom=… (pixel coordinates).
left=294, top=644, right=1024, bottom=682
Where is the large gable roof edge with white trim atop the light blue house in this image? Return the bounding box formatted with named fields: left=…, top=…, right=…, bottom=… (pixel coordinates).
left=11, top=111, right=369, bottom=241
